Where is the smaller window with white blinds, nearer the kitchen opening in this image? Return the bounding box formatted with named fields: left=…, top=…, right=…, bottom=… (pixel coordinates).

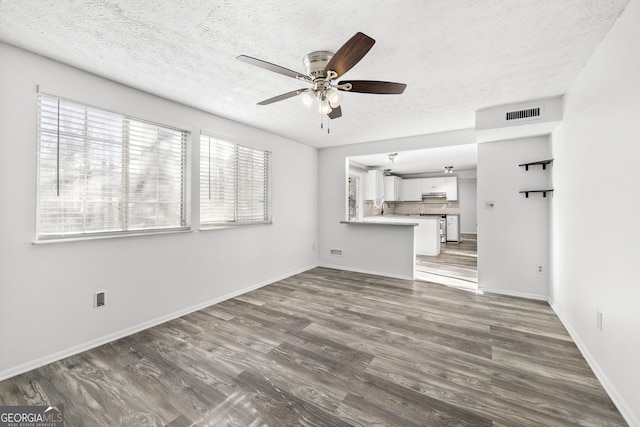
left=200, top=135, right=271, bottom=225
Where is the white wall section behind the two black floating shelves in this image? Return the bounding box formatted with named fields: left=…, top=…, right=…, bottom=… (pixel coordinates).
left=478, top=136, right=551, bottom=300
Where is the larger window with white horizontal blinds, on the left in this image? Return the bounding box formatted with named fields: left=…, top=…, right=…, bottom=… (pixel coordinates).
left=36, top=94, right=189, bottom=240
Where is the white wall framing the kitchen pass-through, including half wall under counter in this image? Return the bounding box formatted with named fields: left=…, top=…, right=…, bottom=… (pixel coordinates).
left=318, top=129, right=475, bottom=279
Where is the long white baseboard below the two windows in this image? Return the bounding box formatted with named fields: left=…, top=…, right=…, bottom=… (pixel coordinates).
left=0, top=264, right=318, bottom=381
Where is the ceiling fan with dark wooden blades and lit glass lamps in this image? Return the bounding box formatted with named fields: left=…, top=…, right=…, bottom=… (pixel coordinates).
left=237, top=32, right=407, bottom=119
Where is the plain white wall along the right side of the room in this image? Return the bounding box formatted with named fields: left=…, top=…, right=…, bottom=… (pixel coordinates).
left=551, top=0, right=640, bottom=426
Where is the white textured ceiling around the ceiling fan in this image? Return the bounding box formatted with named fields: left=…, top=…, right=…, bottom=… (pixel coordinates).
left=0, top=0, right=628, bottom=147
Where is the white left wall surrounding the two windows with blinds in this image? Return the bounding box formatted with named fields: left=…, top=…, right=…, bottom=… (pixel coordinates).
left=0, top=44, right=318, bottom=379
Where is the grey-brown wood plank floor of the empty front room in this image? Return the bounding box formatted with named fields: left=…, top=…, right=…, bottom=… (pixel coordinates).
left=0, top=268, right=626, bottom=427
